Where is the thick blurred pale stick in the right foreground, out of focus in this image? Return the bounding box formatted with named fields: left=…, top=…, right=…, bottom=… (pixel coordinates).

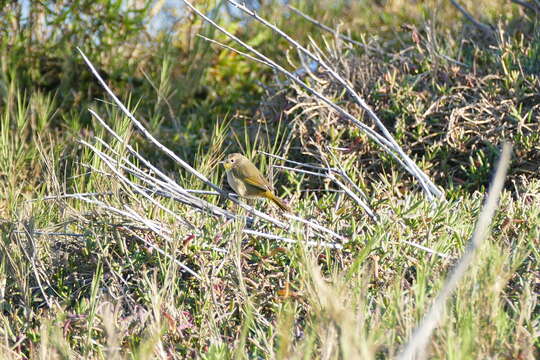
left=398, top=143, right=512, bottom=360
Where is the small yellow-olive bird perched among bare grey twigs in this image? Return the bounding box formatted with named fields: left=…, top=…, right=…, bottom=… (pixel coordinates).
left=221, top=153, right=291, bottom=212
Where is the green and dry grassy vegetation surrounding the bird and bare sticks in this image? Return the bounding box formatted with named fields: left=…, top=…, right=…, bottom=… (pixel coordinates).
left=0, top=0, right=540, bottom=359
